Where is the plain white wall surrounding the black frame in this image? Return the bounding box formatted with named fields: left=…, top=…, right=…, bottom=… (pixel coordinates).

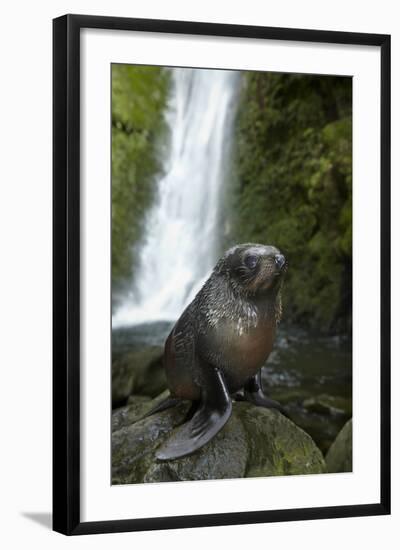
left=0, top=0, right=400, bottom=550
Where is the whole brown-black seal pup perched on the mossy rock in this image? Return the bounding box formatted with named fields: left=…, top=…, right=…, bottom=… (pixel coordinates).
left=149, top=243, right=287, bottom=460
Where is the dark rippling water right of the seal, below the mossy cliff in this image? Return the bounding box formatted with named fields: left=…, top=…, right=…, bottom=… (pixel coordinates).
left=263, top=327, right=352, bottom=452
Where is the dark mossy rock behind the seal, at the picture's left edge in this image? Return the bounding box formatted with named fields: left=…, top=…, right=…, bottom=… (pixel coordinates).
left=112, top=346, right=167, bottom=406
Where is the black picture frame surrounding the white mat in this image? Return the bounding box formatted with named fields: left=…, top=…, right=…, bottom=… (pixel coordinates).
left=53, top=15, right=390, bottom=535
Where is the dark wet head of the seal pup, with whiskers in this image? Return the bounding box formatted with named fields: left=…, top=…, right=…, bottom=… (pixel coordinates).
left=215, top=243, right=287, bottom=295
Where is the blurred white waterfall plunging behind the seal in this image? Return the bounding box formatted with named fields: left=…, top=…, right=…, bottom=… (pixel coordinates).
left=113, top=69, right=237, bottom=327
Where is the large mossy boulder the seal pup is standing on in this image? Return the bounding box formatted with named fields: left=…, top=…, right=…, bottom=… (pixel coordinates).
left=112, top=396, right=326, bottom=484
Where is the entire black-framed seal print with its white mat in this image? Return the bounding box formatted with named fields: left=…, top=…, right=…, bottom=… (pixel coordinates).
left=53, top=15, right=390, bottom=535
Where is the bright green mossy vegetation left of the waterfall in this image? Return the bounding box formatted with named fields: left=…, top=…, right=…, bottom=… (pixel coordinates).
left=112, top=65, right=169, bottom=297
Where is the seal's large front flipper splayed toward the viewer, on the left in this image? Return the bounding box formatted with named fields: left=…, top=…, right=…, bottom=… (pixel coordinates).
left=156, top=367, right=232, bottom=460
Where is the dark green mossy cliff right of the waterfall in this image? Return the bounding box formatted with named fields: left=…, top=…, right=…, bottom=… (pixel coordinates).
left=228, top=72, right=352, bottom=331
